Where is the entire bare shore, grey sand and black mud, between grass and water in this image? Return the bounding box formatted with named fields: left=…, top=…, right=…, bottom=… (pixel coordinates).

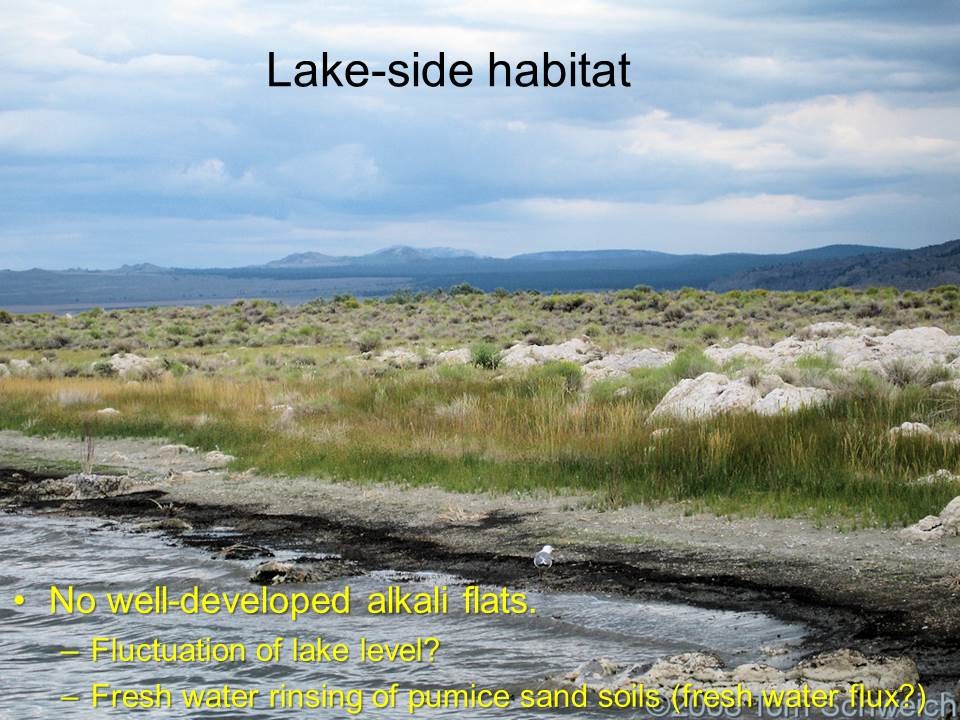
left=0, top=431, right=960, bottom=686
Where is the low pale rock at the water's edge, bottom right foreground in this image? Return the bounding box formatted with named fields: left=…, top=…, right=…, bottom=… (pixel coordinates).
left=547, top=650, right=919, bottom=692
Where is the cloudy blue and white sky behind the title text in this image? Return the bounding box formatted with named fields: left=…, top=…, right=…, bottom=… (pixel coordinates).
left=0, top=0, right=960, bottom=269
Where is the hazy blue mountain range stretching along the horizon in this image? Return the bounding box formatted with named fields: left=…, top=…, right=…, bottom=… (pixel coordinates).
left=0, top=240, right=960, bottom=312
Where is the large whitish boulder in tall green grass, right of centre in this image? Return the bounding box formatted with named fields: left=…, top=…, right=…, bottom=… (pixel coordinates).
left=650, top=373, right=830, bottom=420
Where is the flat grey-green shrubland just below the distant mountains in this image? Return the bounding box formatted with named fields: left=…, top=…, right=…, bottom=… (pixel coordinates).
left=0, top=286, right=960, bottom=362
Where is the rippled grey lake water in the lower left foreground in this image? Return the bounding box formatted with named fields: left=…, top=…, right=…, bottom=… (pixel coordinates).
left=0, top=515, right=806, bottom=720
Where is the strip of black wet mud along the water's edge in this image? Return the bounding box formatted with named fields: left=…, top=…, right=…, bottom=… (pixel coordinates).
left=0, top=463, right=960, bottom=687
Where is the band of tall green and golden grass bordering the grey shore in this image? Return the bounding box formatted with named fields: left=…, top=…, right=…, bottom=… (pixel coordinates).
left=0, top=374, right=960, bottom=526
